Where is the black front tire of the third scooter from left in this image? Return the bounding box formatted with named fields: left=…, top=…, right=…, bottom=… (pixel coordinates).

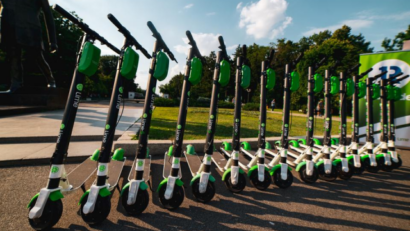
left=121, top=188, right=149, bottom=216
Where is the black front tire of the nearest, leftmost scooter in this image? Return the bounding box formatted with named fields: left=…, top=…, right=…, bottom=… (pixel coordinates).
left=28, top=198, right=63, bottom=230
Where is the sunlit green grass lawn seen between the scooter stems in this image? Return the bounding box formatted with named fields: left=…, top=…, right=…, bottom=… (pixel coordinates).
left=149, top=107, right=351, bottom=140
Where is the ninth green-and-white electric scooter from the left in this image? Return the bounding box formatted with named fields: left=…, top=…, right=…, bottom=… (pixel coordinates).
left=288, top=58, right=326, bottom=184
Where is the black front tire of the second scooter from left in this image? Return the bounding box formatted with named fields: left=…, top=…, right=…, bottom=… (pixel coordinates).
left=80, top=195, right=111, bottom=225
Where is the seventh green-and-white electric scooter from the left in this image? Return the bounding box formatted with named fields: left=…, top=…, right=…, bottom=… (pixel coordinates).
left=239, top=49, right=276, bottom=190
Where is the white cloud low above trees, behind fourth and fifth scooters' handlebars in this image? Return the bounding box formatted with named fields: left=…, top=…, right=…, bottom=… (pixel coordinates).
left=174, top=33, right=237, bottom=55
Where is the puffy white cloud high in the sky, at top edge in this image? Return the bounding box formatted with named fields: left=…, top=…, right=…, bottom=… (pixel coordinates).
left=236, top=0, right=292, bottom=39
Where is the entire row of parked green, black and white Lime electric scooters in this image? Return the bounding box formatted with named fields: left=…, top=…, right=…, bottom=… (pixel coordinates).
left=28, top=5, right=408, bottom=230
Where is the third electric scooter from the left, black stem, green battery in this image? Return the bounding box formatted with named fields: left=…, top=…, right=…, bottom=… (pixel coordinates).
left=121, top=22, right=178, bottom=216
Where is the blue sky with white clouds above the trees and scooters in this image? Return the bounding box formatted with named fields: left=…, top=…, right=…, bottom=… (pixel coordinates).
left=49, top=0, right=410, bottom=89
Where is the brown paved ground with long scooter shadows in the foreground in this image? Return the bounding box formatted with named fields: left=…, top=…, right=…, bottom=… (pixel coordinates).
left=0, top=151, right=410, bottom=230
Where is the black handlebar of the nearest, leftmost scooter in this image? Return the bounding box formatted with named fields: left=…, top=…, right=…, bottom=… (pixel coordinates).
left=53, top=4, right=121, bottom=54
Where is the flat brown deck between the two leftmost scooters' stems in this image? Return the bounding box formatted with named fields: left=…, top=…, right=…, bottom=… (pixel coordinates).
left=67, top=158, right=98, bottom=191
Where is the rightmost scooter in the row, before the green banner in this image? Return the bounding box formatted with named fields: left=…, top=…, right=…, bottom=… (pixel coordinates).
left=373, top=73, right=403, bottom=172
